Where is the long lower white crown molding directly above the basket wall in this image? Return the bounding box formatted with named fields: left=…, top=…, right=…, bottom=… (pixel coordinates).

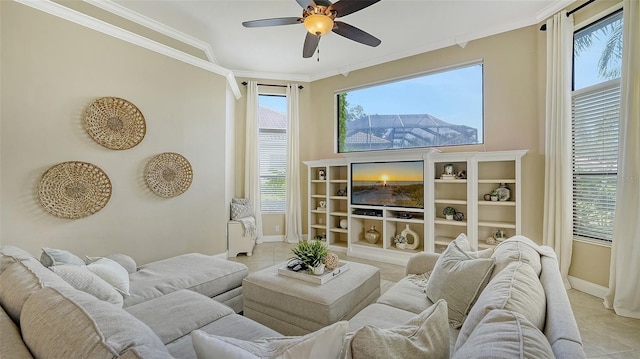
left=15, top=0, right=241, bottom=99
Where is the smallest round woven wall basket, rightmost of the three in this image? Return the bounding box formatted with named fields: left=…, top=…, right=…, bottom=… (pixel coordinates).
left=144, top=152, right=193, bottom=197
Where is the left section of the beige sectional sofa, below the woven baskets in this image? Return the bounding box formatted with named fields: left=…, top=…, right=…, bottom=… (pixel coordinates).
left=0, top=247, right=280, bottom=358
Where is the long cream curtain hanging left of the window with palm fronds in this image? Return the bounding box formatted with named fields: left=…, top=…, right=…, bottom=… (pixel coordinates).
left=542, top=11, right=573, bottom=288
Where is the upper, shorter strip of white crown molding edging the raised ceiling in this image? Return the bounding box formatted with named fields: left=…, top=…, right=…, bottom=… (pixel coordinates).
left=84, top=0, right=218, bottom=64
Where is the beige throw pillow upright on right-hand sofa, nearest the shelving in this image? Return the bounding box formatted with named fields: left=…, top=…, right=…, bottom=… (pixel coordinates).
left=426, top=241, right=494, bottom=329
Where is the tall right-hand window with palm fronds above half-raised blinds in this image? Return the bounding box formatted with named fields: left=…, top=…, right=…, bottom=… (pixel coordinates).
left=572, top=11, right=622, bottom=242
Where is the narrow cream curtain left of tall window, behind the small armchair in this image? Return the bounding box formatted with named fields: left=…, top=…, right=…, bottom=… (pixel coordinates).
left=244, top=81, right=263, bottom=243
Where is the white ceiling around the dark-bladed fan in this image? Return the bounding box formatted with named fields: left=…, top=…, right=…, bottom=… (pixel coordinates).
left=110, top=0, right=574, bottom=81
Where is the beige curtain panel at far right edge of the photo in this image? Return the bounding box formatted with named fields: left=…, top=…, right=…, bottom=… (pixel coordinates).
left=604, top=0, right=640, bottom=319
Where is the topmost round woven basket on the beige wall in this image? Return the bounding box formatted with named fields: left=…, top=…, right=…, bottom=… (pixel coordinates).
left=83, top=97, right=147, bottom=150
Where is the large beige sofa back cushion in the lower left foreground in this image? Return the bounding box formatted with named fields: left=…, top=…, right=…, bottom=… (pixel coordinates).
left=20, top=288, right=167, bottom=358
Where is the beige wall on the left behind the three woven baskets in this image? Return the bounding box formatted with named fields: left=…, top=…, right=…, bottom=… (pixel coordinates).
left=0, top=1, right=233, bottom=263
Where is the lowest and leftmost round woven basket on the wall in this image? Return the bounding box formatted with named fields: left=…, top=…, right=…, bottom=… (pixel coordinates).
left=38, top=161, right=112, bottom=219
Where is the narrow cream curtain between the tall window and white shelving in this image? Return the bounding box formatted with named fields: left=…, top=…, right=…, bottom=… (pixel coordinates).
left=285, top=84, right=302, bottom=243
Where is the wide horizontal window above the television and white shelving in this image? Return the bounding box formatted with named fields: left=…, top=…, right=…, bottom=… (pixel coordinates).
left=336, top=63, right=483, bottom=152
